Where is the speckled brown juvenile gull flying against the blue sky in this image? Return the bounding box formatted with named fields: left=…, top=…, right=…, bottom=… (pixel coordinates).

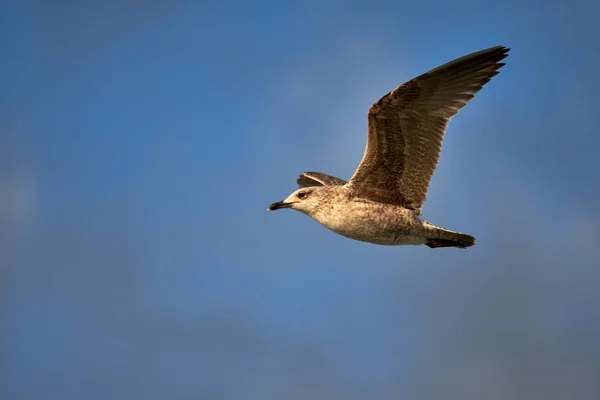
left=268, top=46, right=510, bottom=248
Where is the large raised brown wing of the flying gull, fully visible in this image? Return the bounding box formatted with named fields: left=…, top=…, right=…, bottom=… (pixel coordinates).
left=348, top=46, right=510, bottom=211
